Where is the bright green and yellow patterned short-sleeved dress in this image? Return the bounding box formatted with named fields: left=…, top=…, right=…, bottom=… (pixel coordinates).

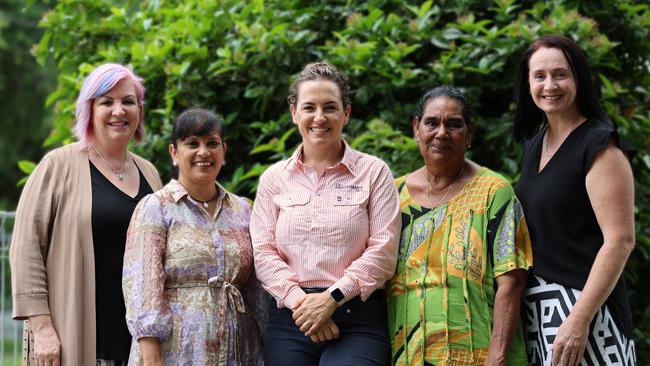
left=388, top=167, right=532, bottom=366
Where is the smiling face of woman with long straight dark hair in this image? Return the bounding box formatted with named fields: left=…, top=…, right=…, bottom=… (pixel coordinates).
left=528, top=47, right=577, bottom=116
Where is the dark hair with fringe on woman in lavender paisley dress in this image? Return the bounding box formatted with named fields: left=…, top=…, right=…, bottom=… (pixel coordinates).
left=171, top=108, right=223, bottom=146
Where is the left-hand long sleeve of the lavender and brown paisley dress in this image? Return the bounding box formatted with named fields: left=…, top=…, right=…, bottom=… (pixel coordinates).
left=122, top=194, right=172, bottom=341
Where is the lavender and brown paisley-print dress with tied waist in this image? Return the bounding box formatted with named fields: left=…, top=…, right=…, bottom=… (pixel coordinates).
left=122, top=180, right=268, bottom=365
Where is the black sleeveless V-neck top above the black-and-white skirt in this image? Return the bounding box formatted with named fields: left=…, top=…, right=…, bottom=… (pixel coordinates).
left=515, top=121, right=632, bottom=337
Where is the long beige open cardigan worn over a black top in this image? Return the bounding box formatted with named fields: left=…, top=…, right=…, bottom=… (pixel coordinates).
left=9, top=143, right=162, bottom=366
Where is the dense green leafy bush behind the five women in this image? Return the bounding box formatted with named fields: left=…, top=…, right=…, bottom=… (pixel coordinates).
left=30, top=0, right=650, bottom=359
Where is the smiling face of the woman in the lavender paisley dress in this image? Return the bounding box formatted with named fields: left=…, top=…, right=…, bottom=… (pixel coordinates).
left=169, top=129, right=227, bottom=189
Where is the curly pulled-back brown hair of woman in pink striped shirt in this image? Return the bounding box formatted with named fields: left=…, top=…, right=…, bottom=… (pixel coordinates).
left=287, top=61, right=352, bottom=108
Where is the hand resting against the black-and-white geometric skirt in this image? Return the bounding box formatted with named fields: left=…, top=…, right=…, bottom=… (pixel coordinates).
left=551, top=314, right=589, bottom=366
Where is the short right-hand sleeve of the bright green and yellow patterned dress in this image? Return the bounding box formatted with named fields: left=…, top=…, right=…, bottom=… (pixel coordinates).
left=488, top=185, right=533, bottom=278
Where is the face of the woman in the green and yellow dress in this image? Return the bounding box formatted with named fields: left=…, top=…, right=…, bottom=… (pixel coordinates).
left=413, top=97, right=474, bottom=163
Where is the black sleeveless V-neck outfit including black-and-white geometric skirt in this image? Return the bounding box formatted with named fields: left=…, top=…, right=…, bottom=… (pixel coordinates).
left=516, top=120, right=636, bottom=365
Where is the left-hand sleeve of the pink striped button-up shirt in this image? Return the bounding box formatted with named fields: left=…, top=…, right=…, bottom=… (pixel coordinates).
left=250, top=170, right=305, bottom=308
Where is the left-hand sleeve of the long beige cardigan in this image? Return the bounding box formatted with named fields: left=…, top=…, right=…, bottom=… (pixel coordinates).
left=9, top=155, right=61, bottom=319
